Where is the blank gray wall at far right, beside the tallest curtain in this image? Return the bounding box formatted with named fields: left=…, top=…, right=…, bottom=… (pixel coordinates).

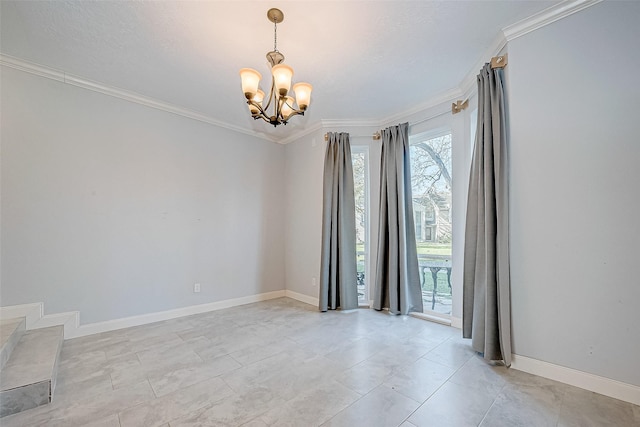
left=508, top=2, right=640, bottom=385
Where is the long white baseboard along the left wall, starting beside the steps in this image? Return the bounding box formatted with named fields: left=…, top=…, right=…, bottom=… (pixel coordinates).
left=65, top=290, right=285, bottom=339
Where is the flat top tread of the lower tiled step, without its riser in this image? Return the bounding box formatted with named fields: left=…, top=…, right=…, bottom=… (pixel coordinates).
left=0, top=326, right=63, bottom=391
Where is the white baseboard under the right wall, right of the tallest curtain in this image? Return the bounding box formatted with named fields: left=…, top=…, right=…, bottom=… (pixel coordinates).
left=511, top=354, right=640, bottom=405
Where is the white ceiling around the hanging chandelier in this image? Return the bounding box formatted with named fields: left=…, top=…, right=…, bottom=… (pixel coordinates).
left=0, top=0, right=559, bottom=140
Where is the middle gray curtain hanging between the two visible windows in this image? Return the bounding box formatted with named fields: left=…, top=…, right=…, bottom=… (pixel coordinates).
left=373, top=123, right=422, bottom=314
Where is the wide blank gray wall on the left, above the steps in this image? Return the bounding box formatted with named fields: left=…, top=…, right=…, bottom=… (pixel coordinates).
left=0, top=67, right=285, bottom=323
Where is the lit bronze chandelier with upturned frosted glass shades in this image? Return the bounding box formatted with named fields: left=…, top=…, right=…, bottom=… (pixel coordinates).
left=240, top=8, right=313, bottom=126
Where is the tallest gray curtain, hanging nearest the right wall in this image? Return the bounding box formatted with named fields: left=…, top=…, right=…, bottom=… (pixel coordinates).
left=462, top=64, right=511, bottom=366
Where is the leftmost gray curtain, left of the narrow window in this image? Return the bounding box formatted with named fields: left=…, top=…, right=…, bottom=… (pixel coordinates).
left=319, top=133, right=358, bottom=311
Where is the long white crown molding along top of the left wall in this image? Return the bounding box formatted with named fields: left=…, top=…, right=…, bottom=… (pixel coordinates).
left=0, top=53, right=279, bottom=143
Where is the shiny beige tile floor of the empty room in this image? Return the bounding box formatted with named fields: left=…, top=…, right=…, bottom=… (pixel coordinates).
left=0, top=298, right=640, bottom=427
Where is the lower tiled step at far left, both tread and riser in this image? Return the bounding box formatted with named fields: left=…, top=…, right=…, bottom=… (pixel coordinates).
left=0, top=326, right=64, bottom=418
